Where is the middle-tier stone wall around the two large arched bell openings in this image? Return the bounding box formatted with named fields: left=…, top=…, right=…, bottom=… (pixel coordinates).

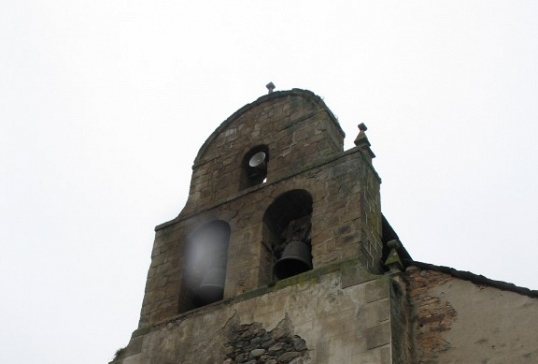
left=140, top=150, right=381, bottom=326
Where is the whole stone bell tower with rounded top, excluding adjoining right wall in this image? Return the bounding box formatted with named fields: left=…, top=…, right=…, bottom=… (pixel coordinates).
left=114, top=89, right=409, bottom=364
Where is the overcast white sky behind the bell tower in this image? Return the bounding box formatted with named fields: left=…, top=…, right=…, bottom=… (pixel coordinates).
left=0, top=0, right=538, bottom=364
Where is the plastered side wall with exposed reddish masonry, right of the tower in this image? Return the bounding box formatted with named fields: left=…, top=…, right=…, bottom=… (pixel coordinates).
left=406, top=267, right=538, bottom=364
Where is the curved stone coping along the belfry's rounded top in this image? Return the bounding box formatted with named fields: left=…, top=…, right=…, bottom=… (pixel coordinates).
left=193, top=88, right=346, bottom=168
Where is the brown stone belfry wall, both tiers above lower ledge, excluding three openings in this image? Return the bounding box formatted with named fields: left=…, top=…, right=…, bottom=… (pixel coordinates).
left=139, top=90, right=382, bottom=327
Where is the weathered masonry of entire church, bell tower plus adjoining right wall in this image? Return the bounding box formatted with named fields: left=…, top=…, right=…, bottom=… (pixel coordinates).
left=111, top=90, right=538, bottom=364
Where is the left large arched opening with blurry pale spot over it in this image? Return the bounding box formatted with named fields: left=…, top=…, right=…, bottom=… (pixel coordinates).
left=179, top=220, right=230, bottom=313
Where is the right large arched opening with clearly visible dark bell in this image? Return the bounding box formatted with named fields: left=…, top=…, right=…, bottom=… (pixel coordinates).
left=260, top=190, right=313, bottom=283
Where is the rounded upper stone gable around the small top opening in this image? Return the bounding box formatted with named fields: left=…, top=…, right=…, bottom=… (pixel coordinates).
left=184, top=91, right=343, bottom=218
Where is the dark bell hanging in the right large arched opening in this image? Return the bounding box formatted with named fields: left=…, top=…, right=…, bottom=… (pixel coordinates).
left=273, top=240, right=312, bottom=279
